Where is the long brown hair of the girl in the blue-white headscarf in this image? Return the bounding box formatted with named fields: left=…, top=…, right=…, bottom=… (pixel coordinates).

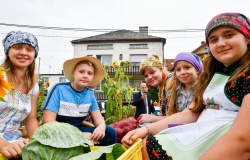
left=3, top=56, right=36, bottom=94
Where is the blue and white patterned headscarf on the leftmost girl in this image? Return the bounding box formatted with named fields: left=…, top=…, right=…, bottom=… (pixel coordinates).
left=3, top=31, right=39, bottom=58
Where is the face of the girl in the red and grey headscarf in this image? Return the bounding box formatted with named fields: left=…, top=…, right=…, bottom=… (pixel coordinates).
left=208, top=27, right=248, bottom=66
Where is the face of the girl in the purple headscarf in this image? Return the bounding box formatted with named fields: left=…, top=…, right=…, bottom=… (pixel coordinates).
left=174, top=61, right=198, bottom=86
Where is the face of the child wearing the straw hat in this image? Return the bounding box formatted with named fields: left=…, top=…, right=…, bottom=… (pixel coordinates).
left=73, top=63, right=94, bottom=88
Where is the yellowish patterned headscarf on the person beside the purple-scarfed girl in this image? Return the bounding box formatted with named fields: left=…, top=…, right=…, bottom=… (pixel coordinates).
left=140, top=55, right=163, bottom=75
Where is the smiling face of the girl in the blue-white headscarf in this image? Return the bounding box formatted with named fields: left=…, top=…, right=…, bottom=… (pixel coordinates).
left=8, top=44, right=35, bottom=68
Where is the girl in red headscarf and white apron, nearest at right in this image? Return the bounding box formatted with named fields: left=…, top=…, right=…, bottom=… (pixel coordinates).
left=122, top=13, right=250, bottom=160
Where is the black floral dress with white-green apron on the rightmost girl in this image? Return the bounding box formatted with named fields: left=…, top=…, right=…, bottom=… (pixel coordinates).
left=146, top=63, right=250, bottom=160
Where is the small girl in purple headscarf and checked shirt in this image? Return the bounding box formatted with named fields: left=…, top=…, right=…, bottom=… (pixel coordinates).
left=167, top=52, right=202, bottom=115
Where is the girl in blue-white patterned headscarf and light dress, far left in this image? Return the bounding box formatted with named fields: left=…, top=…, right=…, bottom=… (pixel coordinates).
left=0, top=31, right=39, bottom=158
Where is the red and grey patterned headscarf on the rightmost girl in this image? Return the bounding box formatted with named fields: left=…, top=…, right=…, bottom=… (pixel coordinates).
left=205, top=12, right=250, bottom=45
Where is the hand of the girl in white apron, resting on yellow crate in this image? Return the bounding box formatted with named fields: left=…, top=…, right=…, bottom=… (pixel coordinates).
left=121, top=127, right=148, bottom=148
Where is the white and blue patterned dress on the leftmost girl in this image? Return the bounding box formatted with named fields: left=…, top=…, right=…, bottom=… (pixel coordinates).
left=0, top=83, right=39, bottom=142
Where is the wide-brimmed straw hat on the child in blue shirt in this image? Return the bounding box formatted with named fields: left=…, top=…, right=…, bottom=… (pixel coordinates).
left=63, top=56, right=105, bottom=86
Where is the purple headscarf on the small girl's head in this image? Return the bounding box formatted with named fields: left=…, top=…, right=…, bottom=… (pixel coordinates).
left=174, top=52, right=202, bottom=73
